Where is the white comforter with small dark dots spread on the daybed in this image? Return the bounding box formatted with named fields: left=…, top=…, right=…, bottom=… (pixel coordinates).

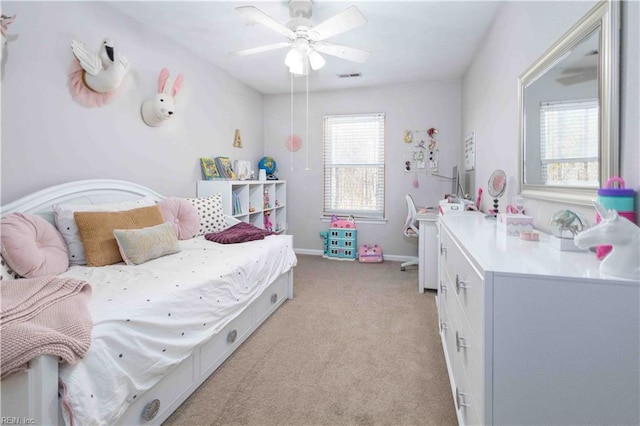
left=60, top=235, right=296, bottom=425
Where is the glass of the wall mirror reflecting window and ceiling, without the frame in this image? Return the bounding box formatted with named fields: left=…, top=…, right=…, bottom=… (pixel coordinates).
left=524, top=26, right=600, bottom=188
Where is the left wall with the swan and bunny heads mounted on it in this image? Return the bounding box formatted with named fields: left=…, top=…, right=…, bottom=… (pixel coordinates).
left=1, top=1, right=263, bottom=204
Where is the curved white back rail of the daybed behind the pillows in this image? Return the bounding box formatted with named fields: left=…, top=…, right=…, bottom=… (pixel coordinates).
left=0, top=179, right=166, bottom=223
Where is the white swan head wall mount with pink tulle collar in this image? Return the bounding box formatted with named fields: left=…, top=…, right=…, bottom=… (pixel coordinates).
left=69, top=38, right=129, bottom=107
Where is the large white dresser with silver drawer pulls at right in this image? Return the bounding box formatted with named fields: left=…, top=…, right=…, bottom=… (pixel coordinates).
left=438, top=213, right=640, bottom=425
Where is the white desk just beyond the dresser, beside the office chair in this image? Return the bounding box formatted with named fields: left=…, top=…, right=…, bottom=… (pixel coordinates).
left=418, top=212, right=438, bottom=293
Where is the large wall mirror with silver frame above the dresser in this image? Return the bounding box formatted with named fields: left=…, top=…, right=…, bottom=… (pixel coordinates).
left=519, top=0, right=620, bottom=204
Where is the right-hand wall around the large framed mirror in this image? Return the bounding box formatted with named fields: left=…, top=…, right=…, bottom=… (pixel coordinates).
left=462, top=1, right=640, bottom=231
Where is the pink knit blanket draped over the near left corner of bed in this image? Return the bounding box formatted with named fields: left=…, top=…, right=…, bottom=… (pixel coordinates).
left=0, top=276, right=93, bottom=379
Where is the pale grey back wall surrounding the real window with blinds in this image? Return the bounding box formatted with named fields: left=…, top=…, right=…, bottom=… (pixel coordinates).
left=264, top=80, right=462, bottom=256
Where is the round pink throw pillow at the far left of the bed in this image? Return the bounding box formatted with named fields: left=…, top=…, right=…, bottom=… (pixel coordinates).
left=0, top=213, right=69, bottom=278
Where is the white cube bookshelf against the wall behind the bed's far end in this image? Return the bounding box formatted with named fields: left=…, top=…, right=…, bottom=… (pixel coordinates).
left=196, top=180, right=287, bottom=233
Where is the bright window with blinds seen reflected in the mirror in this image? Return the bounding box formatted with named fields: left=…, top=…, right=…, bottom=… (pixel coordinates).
left=540, top=99, right=600, bottom=186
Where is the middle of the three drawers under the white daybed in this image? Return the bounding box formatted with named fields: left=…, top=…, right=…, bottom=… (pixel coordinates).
left=200, top=308, right=252, bottom=374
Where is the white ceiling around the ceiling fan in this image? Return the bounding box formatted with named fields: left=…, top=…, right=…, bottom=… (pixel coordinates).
left=109, top=0, right=501, bottom=94
